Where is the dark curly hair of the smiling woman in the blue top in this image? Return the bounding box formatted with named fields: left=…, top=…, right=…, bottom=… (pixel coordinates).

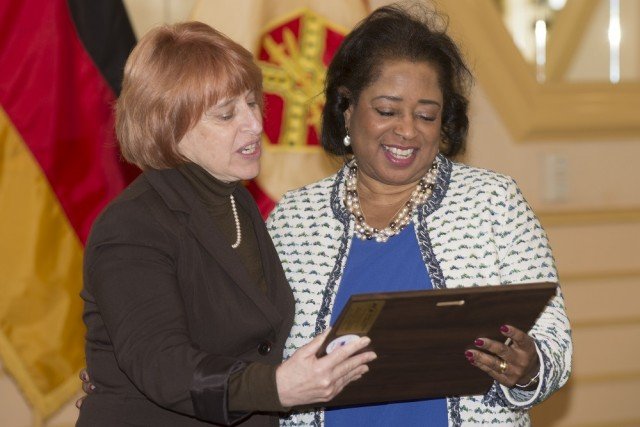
left=322, top=4, right=473, bottom=157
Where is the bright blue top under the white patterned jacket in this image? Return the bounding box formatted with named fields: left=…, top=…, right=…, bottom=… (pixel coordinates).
left=325, top=223, right=448, bottom=427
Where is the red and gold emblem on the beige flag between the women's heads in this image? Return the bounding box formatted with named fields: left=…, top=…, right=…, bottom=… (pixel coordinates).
left=258, top=9, right=346, bottom=150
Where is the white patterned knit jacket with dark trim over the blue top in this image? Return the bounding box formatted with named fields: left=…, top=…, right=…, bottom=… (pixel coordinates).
left=268, top=156, right=572, bottom=426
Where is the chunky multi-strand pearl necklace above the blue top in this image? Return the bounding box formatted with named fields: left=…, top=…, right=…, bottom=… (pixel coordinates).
left=344, top=159, right=438, bottom=242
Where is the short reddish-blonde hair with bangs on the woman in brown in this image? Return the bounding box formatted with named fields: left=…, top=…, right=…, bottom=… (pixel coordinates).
left=116, top=22, right=262, bottom=170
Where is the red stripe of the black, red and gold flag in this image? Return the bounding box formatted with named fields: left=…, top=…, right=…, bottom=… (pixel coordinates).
left=0, top=0, right=133, bottom=243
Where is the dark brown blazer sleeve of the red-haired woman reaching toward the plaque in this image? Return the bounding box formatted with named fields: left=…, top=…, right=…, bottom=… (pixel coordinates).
left=85, top=203, right=249, bottom=425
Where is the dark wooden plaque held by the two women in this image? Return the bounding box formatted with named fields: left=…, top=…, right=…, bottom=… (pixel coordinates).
left=318, top=283, right=557, bottom=407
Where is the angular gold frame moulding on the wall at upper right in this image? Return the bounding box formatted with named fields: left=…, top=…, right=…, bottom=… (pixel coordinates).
left=438, top=0, right=640, bottom=141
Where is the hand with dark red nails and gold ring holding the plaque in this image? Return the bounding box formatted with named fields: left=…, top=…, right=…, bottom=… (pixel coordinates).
left=465, top=325, right=540, bottom=388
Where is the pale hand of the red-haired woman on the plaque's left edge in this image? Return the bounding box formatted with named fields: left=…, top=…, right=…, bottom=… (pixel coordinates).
left=276, top=330, right=377, bottom=407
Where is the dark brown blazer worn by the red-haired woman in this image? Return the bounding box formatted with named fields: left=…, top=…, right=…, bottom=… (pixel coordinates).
left=77, top=169, right=294, bottom=427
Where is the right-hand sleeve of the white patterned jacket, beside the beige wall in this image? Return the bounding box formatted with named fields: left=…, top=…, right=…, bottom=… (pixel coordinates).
left=489, top=179, right=573, bottom=409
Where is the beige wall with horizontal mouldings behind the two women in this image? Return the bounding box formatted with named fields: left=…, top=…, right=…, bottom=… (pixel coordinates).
left=0, top=0, right=640, bottom=427
